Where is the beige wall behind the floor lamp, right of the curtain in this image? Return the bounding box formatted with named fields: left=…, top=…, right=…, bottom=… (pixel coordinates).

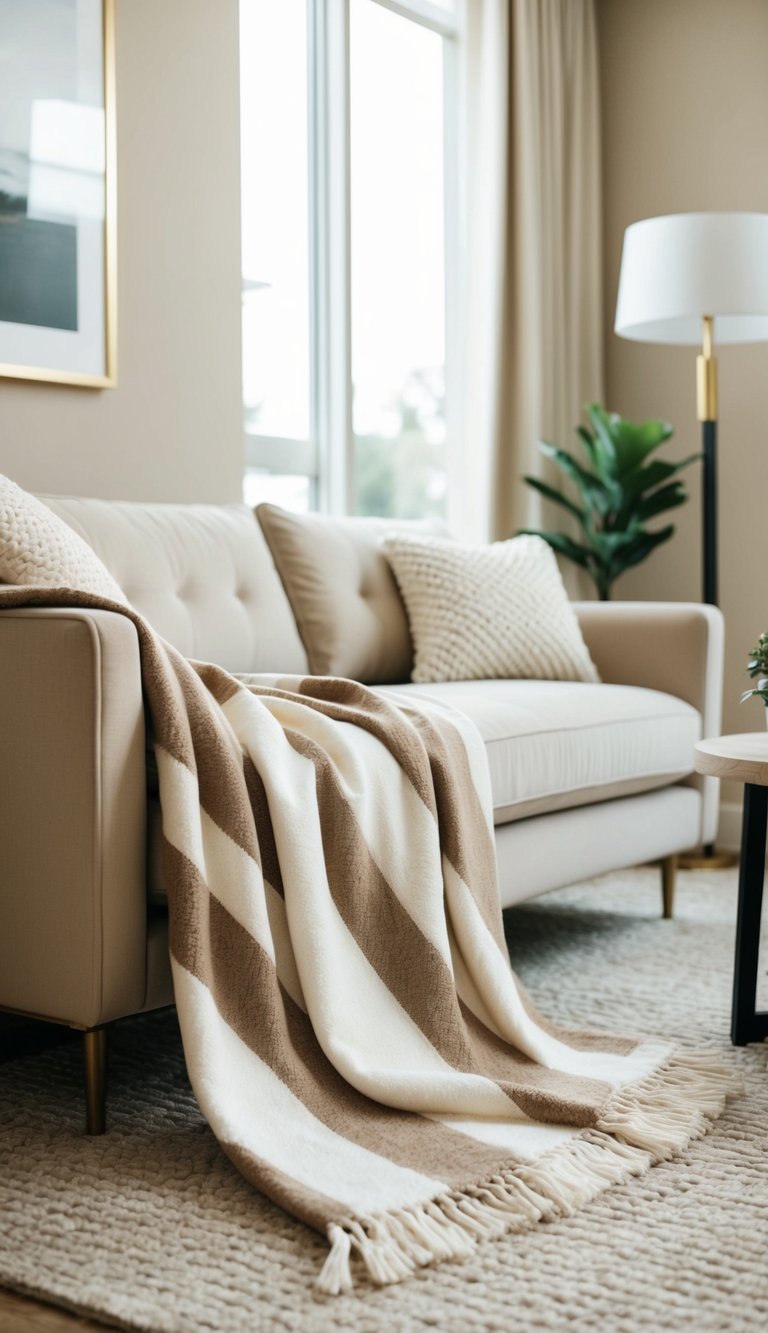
left=597, top=0, right=768, bottom=797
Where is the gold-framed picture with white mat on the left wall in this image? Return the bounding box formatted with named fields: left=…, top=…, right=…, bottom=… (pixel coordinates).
left=0, top=0, right=117, bottom=388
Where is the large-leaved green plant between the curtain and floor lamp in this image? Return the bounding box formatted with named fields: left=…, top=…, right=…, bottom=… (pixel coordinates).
left=523, top=403, right=700, bottom=601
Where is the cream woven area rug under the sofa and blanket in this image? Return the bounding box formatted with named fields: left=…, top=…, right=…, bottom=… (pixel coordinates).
left=0, top=870, right=768, bottom=1333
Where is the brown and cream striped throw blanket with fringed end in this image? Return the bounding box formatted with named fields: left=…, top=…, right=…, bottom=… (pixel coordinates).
left=0, top=588, right=732, bottom=1294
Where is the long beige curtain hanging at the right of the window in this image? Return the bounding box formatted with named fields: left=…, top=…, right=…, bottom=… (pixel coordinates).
left=452, top=0, right=603, bottom=551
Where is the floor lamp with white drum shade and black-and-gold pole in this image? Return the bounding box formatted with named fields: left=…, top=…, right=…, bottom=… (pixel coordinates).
left=615, top=213, right=768, bottom=868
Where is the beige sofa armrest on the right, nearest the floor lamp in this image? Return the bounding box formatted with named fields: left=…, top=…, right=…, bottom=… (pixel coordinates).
left=573, top=601, right=724, bottom=842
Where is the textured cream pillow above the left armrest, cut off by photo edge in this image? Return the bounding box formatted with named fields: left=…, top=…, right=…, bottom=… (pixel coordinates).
left=0, top=476, right=131, bottom=607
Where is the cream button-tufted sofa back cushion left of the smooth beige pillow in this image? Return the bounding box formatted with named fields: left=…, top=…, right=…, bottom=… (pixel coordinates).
left=40, top=496, right=307, bottom=673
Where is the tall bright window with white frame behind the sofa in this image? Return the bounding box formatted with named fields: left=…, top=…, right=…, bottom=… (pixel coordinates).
left=240, top=0, right=460, bottom=517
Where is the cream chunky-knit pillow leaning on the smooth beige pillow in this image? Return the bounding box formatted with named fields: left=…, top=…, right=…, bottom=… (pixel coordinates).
left=383, top=536, right=599, bottom=681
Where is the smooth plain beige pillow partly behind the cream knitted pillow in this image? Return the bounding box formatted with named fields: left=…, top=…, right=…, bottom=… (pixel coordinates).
left=256, top=504, right=433, bottom=685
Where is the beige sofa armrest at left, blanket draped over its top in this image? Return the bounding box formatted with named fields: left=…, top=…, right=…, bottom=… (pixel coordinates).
left=0, top=607, right=147, bottom=1026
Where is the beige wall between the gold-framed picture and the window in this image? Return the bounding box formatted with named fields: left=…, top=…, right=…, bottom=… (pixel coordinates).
left=0, top=0, right=243, bottom=501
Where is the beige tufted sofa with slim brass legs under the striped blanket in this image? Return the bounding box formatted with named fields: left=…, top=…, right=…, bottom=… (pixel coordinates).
left=0, top=497, right=723, bottom=1133
